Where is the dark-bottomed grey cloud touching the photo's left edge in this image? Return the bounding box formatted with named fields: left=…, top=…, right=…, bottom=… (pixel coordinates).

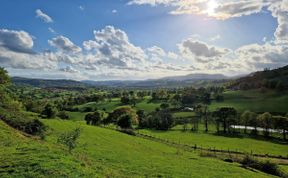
left=0, top=29, right=33, bottom=53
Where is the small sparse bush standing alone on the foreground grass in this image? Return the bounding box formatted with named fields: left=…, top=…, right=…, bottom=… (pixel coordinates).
left=57, top=128, right=80, bottom=153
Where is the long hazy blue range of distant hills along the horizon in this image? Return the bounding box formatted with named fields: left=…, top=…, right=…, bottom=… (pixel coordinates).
left=12, top=74, right=230, bottom=88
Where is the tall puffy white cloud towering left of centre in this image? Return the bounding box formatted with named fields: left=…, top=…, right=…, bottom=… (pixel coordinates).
left=83, top=26, right=147, bottom=68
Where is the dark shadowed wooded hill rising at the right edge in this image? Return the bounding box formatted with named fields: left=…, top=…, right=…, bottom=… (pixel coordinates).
left=229, top=65, right=288, bottom=90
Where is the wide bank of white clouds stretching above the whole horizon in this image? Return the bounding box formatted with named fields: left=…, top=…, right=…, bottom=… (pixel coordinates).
left=0, top=19, right=288, bottom=80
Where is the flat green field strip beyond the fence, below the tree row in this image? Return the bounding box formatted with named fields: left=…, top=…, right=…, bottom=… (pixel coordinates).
left=141, top=130, right=288, bottom=156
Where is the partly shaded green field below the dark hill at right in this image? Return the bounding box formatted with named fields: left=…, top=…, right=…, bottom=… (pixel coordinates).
left=209, top=91, right=288, bottom=113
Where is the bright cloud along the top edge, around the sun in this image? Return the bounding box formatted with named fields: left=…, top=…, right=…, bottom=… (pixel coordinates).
left=128, top=0, right=270, bottom=20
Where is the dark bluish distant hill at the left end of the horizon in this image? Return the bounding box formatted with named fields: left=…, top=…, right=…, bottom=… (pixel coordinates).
left=12, top=77, right=87, bottom=88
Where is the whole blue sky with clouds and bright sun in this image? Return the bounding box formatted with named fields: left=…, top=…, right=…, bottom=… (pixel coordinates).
left=0, top=0, right=288, bottom=80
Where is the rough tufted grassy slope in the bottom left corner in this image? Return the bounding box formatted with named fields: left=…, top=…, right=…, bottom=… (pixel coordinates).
left=0, top=121, right=97, bottom=177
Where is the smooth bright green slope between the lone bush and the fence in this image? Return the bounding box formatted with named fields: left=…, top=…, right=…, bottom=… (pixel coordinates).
left=44, top=120, right=274, bottom=177
